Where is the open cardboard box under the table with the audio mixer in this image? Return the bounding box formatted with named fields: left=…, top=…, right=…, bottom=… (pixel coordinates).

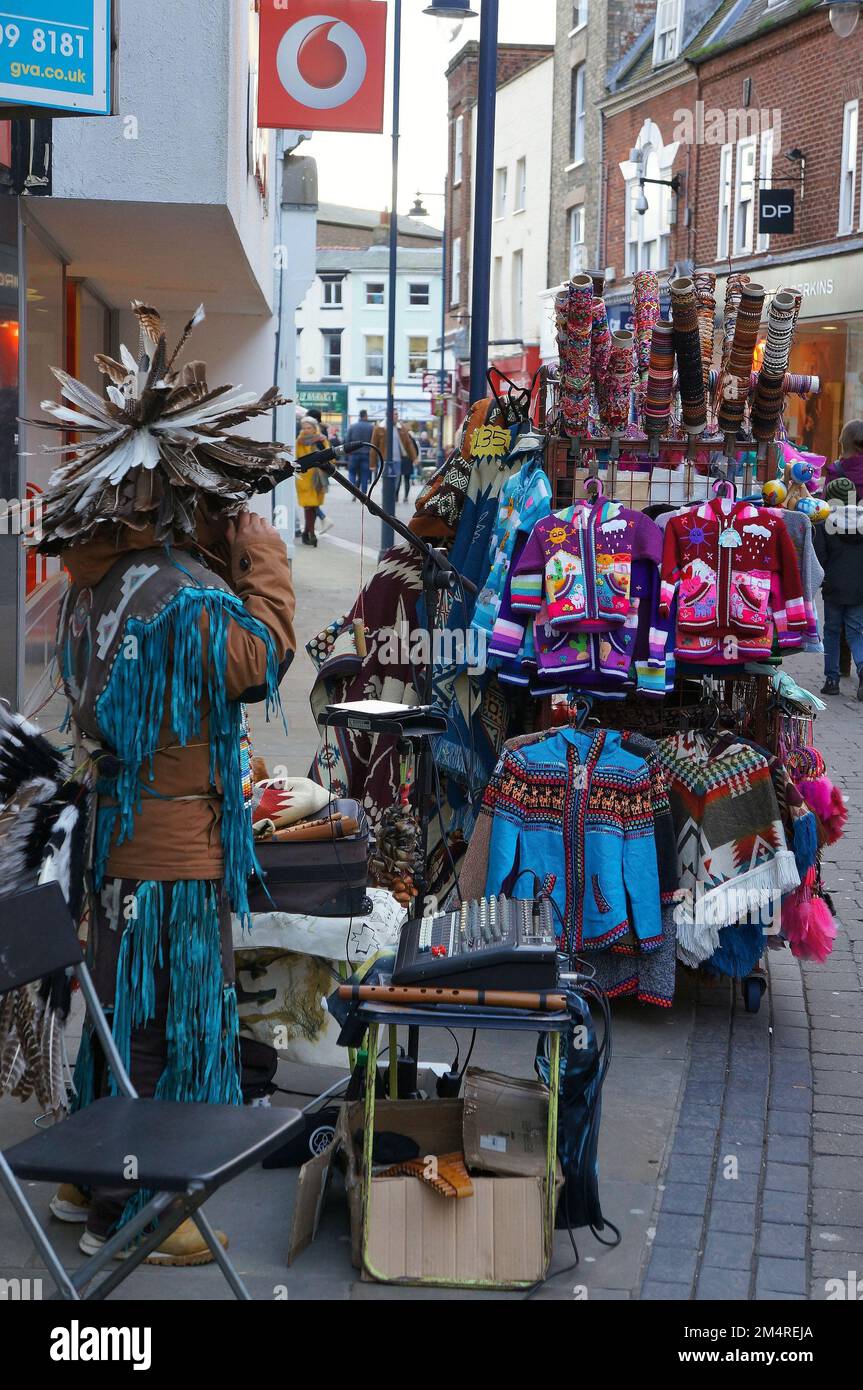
left=288, top=1072, right=550, bottom=1289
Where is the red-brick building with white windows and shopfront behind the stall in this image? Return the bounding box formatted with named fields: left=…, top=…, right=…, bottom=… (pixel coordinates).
left=602, top=0, right=863, bottom=455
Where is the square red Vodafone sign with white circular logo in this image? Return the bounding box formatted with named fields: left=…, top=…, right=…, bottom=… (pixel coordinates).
left=257, top=0, right=386, bottom=133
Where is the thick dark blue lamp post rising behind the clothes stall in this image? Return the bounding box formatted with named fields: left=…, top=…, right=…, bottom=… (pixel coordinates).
left=471, top=0, right=498, bottom=400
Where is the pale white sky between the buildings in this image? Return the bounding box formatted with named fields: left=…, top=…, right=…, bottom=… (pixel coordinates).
left=302, top=0, right=556, bottom=227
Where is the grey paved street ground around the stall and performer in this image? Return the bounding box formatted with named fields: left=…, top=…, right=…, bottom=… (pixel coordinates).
left=0, top=488, right=863, bottom=1301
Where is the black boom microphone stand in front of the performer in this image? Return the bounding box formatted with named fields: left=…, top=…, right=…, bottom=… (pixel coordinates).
left=302, top=443, right=479, bottom=917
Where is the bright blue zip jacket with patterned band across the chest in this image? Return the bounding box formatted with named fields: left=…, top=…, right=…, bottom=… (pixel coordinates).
left=484, top=728, right=661, bottom=951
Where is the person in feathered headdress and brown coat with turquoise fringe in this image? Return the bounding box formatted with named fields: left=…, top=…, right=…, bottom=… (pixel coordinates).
left=31, top=302, right=295, bottom=1264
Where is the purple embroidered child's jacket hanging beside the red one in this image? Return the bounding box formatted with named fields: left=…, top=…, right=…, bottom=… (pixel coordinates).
left=511, top=502, right=661, bottom=632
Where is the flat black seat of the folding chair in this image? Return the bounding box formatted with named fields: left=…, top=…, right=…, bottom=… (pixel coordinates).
left=4, top=1095, right=303, bottom=1193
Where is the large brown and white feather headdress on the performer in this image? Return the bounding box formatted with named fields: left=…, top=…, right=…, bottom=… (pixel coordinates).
left=28, top=299, right=286, bottom=555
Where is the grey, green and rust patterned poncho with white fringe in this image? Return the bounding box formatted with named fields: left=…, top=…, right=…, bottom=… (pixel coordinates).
left=656, top=734, right=800, bottom=965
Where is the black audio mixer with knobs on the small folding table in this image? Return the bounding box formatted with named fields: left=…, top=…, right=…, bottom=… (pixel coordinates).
left=392, top=898, right=557, bottom=990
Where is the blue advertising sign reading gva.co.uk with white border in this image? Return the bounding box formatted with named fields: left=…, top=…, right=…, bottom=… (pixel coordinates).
left=0, top=0, right=111, bottom=117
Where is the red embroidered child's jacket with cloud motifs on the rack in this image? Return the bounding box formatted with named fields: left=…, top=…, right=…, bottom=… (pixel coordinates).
left=660, top=498, right=806, bottom=660
